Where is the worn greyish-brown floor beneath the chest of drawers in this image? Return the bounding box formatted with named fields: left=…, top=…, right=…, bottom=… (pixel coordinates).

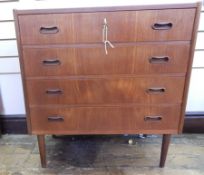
left=0, top=135, right=204, bottom=175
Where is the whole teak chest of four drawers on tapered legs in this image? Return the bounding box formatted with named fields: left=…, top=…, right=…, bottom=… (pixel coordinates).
left=14, top=3, right=201, bottom=167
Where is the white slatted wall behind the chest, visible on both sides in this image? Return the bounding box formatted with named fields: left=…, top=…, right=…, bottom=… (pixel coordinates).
left=0, top=0, right=204, bottom=115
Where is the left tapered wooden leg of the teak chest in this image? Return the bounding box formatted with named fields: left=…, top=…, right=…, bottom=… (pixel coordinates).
left=37, top=135, right=47, bottom=168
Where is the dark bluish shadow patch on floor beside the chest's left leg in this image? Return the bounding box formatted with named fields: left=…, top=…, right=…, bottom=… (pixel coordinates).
left=47, top=136, right=105, bottom=168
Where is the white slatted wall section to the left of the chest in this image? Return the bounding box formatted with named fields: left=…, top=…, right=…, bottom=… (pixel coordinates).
left=0, top=0, right=25, bottom=115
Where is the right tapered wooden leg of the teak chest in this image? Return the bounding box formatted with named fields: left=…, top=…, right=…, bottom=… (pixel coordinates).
left=159, top=134, right=171, bottom=168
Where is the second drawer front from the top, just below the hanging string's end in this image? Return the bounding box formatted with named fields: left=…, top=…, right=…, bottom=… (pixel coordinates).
left=23, top=44, right=189, bottom=76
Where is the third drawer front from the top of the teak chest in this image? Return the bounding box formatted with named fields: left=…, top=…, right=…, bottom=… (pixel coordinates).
left=26, top=76, right=185, bottom=105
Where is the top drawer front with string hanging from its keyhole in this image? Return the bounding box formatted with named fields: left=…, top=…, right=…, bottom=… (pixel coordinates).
left=19, top=9, right=195, bottom=44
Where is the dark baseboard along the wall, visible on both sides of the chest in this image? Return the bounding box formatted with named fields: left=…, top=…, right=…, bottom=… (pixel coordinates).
left=0, top=112, right=204, bottom=134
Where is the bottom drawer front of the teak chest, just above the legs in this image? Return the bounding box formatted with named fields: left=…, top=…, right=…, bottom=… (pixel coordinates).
left=30, top=106, right=180, bottom=134
